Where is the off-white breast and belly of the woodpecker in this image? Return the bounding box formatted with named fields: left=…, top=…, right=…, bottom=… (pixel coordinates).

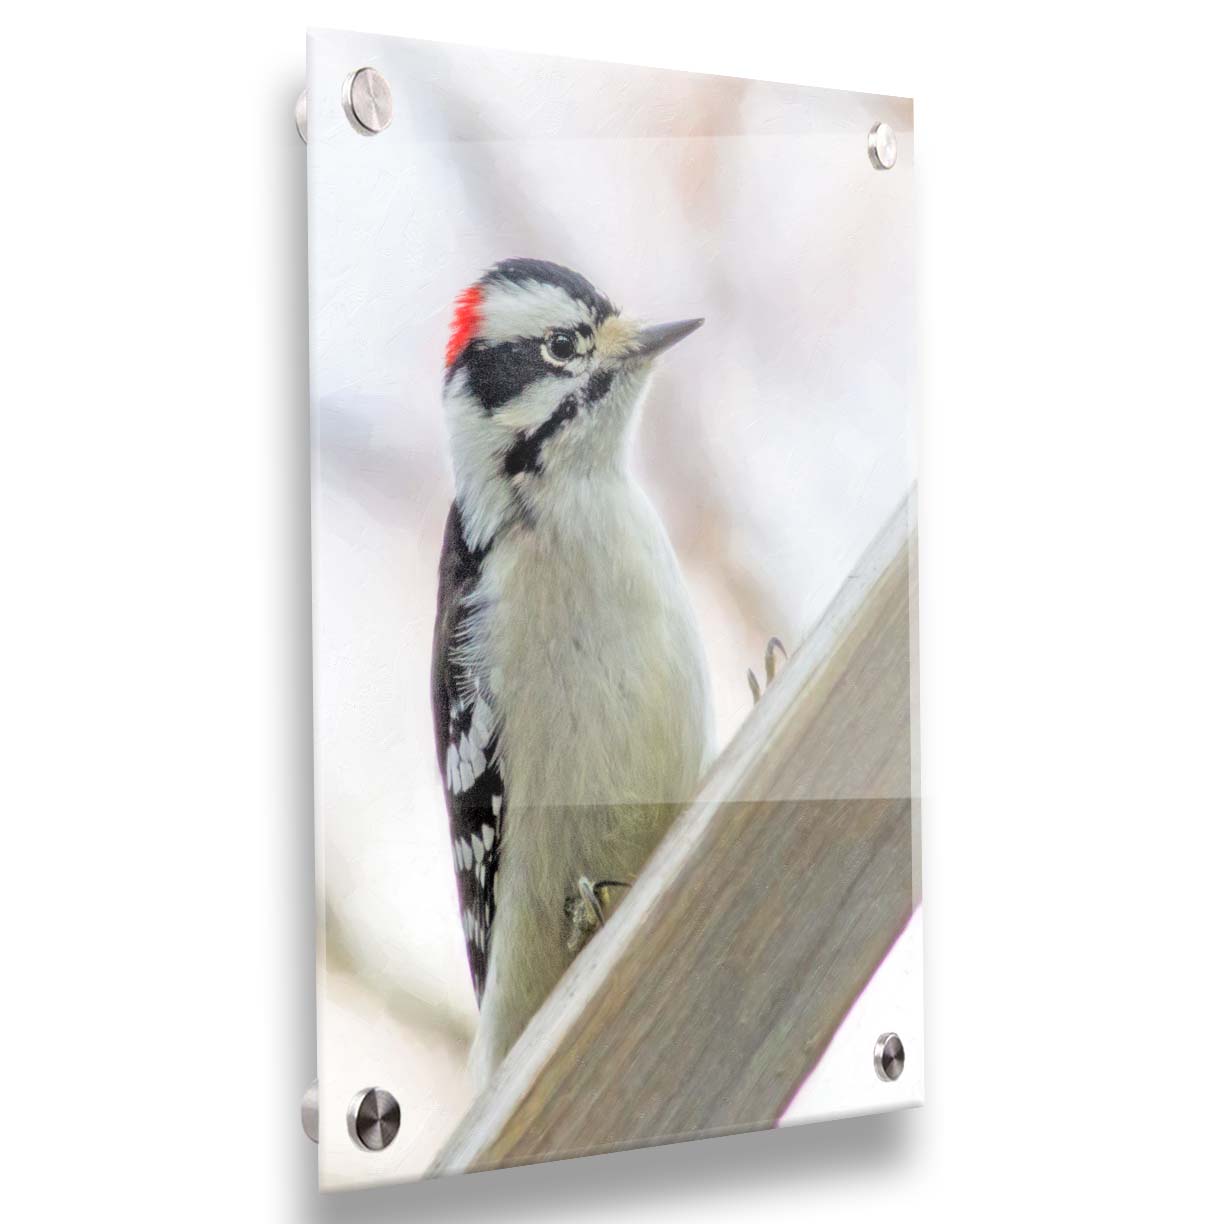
left=470, top=472, right=712, bottom=1080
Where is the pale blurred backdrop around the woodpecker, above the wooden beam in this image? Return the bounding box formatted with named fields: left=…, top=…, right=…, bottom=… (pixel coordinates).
left=307, top=33, right=914, bottom=1186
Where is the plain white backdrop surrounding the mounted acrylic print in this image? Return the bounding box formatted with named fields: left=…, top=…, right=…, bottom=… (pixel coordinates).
left=0, top=0, right=1224, bottom=1224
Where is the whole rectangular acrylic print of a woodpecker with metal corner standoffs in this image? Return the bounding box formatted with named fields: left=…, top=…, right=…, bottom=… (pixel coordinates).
left=306, top=32, right=923, bottom=1189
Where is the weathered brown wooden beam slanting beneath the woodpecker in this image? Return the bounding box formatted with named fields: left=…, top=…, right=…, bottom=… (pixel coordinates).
left=431, top=502, right=917, bottom=1174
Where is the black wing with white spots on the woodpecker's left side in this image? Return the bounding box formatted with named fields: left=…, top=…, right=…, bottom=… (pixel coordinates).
left=432, top=504, right=506, bottom=1000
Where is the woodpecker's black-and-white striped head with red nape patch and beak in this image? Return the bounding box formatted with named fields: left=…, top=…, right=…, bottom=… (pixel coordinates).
left=443, top=259, right=703, bottom=547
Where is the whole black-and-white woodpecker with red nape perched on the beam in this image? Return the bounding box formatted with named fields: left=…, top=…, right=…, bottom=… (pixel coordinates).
left=431, top=258, right=714, bottom=1086
